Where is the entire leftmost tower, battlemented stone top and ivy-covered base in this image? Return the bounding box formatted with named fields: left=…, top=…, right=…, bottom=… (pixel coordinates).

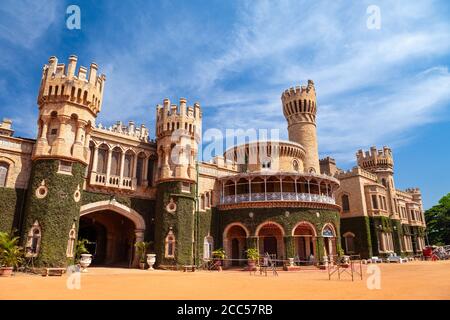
left=23, top=55, right=105, bottom=267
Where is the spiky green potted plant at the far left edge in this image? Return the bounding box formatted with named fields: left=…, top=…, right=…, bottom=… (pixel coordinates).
left=0, top=232, right=23, bottom=277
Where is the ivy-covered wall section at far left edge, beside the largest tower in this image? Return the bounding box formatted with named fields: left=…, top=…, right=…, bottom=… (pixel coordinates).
left=0, top=188, right=27, bottom=233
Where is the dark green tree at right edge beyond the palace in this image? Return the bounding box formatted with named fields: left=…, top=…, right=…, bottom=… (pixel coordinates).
left=425, top=193, right=450, bottom=245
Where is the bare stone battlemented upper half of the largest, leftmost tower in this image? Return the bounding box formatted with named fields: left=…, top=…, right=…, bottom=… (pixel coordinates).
left=33, top=55, right=105, bottom=164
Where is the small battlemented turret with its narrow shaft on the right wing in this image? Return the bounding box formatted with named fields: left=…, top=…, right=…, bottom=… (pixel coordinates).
left=356, top=146, right=400, bottom=219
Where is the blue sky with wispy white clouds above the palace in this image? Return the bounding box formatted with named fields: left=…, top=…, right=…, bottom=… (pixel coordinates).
left=0, top=0, right=450, bottom=208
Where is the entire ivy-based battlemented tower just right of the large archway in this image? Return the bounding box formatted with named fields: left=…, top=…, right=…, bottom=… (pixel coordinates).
left=155, top=98, right=202, bottom=268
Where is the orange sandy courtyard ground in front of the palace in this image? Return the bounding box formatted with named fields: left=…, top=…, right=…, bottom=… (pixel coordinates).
left=0, top=261, right=450, bottom=300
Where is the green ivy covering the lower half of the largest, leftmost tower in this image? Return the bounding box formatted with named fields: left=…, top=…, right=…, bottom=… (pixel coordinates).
left=22, top=160, right=86, bottom=267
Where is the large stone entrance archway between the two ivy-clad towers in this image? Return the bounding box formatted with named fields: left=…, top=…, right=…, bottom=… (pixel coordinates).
left=79, top=200, right=145, bottom=266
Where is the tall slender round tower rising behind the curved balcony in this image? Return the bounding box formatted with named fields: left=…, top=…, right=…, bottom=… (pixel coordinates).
left=281, top=80, right=320, bottom=173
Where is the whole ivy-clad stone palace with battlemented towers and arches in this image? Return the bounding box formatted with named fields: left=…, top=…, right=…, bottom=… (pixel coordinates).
left=0, top=56, right=425, bottom=268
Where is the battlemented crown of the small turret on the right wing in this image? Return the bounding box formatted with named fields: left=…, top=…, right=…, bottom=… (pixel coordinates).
left=356, top=146, right=394, bottom=172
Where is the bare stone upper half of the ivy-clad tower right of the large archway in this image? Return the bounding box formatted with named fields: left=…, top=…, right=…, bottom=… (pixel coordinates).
left=155, top=98, right=202, bottom=182
